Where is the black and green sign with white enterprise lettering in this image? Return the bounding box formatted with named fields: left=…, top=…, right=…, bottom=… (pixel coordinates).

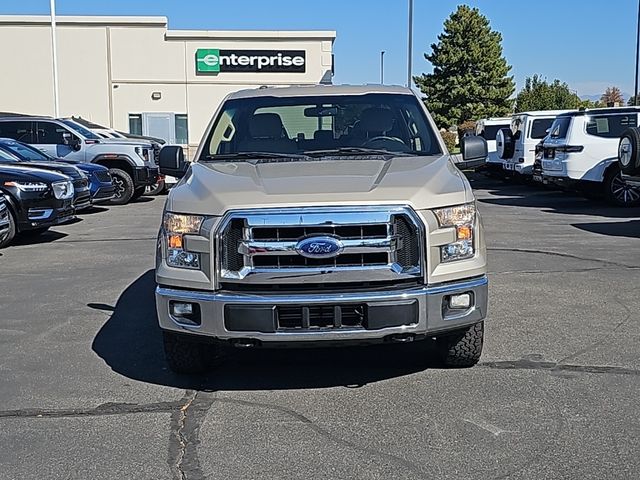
left=196, top=48, right=306, bottom=74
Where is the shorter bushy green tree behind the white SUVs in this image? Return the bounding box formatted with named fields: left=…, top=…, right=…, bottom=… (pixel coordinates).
left=516, top=75, right=582, bottom=112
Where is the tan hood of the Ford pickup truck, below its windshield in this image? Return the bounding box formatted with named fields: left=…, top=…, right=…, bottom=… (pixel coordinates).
left=167, top=155, right=472, bottom=215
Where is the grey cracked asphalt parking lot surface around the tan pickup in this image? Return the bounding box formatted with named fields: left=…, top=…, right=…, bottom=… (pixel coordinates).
left=0, top=176, right=640, bottom=479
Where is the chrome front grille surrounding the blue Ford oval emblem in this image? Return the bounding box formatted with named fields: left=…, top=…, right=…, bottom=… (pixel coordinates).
left=217, top=206, right=424, bottom=288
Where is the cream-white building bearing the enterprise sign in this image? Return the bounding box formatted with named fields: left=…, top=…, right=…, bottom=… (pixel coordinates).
left=0, top=15, right=336, bottom=154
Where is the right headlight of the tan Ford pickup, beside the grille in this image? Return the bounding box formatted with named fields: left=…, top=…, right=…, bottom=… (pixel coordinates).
left=433, top=203, right=476, bottom=262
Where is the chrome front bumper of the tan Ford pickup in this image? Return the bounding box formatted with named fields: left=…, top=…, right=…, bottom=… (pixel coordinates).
left=156, top=276, right=488, bottom=344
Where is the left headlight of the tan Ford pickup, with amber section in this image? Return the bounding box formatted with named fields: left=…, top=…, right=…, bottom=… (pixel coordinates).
left=162, top=212, right=204, bottom=270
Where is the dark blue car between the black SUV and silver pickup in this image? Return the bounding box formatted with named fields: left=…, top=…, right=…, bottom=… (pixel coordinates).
left=0, top=138, right=115, bottom=204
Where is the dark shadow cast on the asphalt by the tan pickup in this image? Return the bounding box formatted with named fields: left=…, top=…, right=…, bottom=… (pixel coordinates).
left=88, top=270, right=435, bottom=391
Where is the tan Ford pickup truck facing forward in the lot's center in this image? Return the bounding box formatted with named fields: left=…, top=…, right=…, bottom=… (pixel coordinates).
left=156, top=86, right=487, bottom=372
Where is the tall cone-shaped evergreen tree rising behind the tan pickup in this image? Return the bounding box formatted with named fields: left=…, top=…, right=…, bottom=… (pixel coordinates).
left=414, top=5, right=515, bottom=128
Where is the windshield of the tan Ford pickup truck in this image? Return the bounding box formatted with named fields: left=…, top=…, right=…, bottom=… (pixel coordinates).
left=202, top=94, right=442, bottom=160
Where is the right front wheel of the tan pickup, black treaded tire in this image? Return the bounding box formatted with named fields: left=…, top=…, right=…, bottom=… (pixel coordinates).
left=436, top=322, right=484, bottom=367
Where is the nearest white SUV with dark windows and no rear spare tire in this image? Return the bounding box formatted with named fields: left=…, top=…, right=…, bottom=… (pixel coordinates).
left=542, top=107, right=640, bottom=206
